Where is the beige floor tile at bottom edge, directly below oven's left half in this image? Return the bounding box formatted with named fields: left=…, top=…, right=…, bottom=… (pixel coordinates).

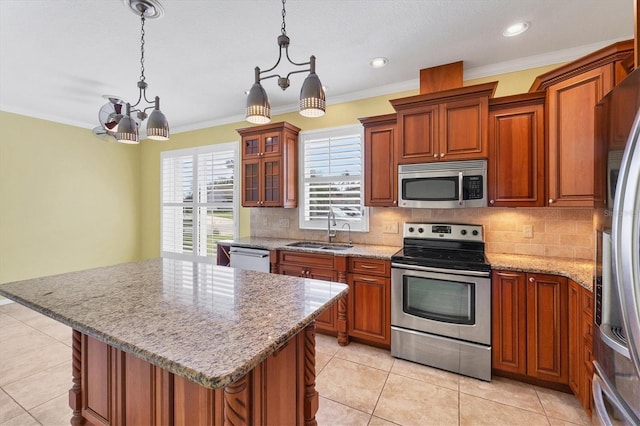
left=373, top=374, right=458, bottom=426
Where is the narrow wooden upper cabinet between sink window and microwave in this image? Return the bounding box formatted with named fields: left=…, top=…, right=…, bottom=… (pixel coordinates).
left=359, top=114, right=398, bottom=207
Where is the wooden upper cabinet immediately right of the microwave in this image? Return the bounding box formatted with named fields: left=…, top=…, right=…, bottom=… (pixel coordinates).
left=487, top=92, right=545, bottom=207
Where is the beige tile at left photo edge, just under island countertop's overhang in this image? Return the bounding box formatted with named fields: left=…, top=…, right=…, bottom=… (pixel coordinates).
left=0, top=333, right=71, bottom=386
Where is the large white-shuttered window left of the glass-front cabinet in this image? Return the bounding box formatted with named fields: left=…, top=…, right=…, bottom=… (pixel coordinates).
left=160, top=142, right=238, bottom=262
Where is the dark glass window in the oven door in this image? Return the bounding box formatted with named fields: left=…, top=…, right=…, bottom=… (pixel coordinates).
left=402, top=275, right=475, bottom=325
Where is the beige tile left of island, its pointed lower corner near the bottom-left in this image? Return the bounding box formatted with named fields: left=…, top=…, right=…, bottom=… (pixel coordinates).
left=3, top=358, right=72, bottom=410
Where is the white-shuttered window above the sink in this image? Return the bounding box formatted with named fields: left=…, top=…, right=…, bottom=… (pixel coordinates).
left=299, top=125, right=369, bottom=231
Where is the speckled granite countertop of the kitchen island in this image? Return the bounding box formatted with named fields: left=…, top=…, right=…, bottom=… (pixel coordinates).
left=0, top=258, right=347, bottom=389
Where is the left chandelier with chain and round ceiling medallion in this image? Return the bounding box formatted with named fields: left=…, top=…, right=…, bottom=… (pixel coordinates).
left=116, top=0, right=169, bottom=144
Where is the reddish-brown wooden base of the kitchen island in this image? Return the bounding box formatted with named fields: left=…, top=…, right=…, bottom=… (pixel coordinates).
left=69, top=325, right=318, bottom=426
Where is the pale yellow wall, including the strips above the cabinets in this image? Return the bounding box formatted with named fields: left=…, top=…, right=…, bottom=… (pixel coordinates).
left=0, top=67, right=554, bottom=276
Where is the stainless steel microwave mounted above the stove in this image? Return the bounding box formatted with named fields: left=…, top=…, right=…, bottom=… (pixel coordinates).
left=398, top=160, right=487, bottom=209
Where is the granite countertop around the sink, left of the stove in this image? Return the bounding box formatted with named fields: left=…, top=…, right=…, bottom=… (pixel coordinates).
left=220, top=237, right=401, bottom=260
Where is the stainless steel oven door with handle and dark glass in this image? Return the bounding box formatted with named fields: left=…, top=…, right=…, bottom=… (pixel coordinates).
left=391, top=263, right=491, bottom=345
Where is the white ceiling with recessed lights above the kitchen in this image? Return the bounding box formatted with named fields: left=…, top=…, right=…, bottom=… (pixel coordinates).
left=0, top=0, right=634, bottom=133
